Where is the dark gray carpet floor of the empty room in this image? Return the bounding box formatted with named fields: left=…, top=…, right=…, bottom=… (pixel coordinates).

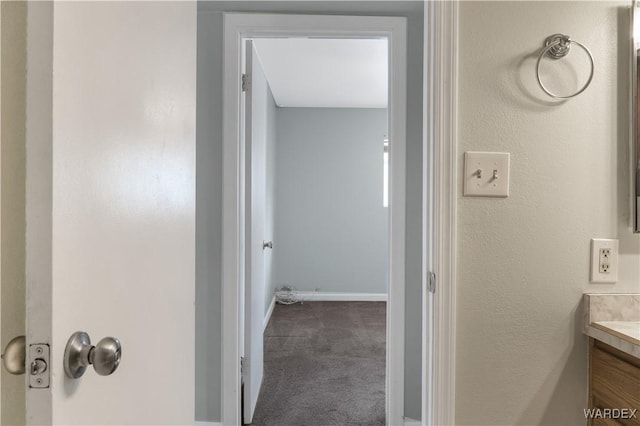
left=252, top=302, right=386, bottom=426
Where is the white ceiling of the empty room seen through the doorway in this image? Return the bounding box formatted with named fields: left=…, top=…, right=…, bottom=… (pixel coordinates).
left=254, top=38, right=388, bottom=108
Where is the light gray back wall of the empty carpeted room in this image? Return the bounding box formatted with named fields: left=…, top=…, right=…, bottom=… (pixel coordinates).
left=274, top=108, right=389, bottom=293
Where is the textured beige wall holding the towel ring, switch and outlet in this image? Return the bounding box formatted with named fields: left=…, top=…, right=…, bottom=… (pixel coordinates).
left=456, top=1, right=640, bottom=425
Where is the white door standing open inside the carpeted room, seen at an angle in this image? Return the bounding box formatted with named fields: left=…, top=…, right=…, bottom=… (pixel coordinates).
left=243, top=40, right=268, bottom=423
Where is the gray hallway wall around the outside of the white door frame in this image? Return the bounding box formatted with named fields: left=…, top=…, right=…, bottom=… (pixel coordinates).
left=196, top=1, right=424, bottom=422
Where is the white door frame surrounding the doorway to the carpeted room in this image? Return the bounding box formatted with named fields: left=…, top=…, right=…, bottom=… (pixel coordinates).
left=222, top=13, right=407, bottom=425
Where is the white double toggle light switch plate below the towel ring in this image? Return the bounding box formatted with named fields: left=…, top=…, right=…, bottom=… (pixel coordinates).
left=464, top=152, right=510, bottom=197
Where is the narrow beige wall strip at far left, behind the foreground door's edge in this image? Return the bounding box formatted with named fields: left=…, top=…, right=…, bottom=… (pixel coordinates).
left=0, top=2, right=27, bottom=424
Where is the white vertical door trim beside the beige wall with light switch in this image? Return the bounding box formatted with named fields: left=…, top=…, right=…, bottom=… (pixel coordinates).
left=422, top=0, right=458, bottom=425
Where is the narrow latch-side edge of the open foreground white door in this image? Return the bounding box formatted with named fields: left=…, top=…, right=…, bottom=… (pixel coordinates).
left=25, top=2, right=54, bottom=425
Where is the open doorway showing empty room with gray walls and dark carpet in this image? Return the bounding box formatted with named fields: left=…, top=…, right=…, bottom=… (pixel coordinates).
left=242, top=37, right=389, bottom=425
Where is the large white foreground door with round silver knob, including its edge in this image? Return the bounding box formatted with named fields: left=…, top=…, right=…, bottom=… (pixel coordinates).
left=26, top=2, right=197, bottom=425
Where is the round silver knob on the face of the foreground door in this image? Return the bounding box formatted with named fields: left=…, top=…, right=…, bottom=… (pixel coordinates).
left=63, top=331, right=122, bottom=379
